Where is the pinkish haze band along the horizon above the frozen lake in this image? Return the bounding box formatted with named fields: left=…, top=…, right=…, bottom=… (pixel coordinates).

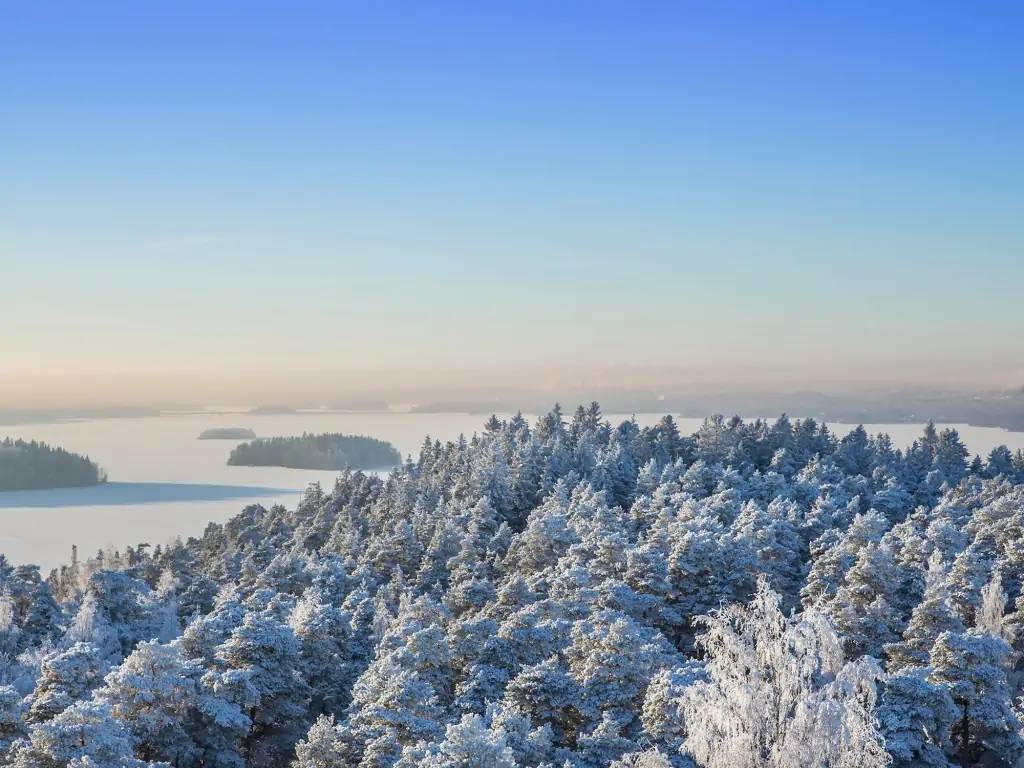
left=0, top=366, right=1024, bottom=410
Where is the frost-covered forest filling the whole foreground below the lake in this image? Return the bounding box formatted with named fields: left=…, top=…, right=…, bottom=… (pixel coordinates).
left=0, top=403, right=1024, bottom=768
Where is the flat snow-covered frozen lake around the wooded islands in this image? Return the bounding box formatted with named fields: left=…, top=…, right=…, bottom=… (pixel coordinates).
left=0, top=413, right=1024, bottom=572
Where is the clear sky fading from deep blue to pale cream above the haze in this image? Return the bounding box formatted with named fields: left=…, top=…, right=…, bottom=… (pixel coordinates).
left=0, top=0, right=1024, bottom=384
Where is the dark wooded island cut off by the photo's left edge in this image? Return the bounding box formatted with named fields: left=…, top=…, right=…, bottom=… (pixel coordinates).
left=0, top=437, right=106, bottom=490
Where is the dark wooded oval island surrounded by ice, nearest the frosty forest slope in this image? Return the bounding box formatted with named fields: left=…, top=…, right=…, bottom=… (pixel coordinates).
left=227, top=433, right=401, bottom=470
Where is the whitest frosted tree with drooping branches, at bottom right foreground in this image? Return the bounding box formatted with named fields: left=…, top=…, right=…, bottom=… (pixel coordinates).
left=683, top=580, right=888, bottom=768
